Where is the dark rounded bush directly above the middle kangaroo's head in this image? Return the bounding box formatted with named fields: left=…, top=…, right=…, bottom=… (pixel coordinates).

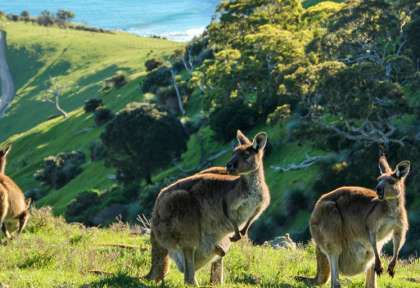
left=209, top=100, right=257, bottom=141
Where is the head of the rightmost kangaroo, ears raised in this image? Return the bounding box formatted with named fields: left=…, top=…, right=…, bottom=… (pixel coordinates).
left=376, top=155, right=410, bottom=199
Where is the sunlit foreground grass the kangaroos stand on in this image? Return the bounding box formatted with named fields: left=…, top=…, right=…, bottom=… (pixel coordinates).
left=0, top=209, right=420, bottom=288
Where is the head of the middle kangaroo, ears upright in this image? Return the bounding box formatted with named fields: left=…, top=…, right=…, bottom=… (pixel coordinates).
left=226, top=130, right=267, bottom=175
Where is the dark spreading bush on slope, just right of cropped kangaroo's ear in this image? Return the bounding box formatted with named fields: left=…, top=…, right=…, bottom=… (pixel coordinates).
left=34, top=151, right=86, bottom=189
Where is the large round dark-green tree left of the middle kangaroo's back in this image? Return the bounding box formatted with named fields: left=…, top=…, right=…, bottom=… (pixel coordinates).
left=101, top=102, right=187, bottom=184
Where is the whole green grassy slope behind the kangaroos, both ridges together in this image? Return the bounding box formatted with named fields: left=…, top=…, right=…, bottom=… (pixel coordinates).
left=0, top=22, right=182, bottom=212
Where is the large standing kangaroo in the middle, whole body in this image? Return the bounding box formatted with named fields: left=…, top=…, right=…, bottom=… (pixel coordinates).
left=146, top=131, right=270, bottom=285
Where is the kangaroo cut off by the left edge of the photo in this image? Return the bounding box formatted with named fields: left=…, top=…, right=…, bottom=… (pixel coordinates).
left=0, top=146, right=31, bottom=239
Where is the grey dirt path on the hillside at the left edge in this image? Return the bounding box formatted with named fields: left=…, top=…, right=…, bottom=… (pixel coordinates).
left=0, top=31, right=16, bottom=118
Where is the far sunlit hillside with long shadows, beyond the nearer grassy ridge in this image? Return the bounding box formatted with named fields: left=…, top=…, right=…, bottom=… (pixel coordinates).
left=0, top=21, right=180, bottom=140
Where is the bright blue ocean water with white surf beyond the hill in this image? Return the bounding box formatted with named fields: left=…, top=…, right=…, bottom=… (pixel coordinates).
left=0, top=0, right=219, bottom=41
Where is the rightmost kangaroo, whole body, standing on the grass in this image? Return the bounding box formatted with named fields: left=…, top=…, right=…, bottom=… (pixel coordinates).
left=301, top=155, right=410, bottom=288
